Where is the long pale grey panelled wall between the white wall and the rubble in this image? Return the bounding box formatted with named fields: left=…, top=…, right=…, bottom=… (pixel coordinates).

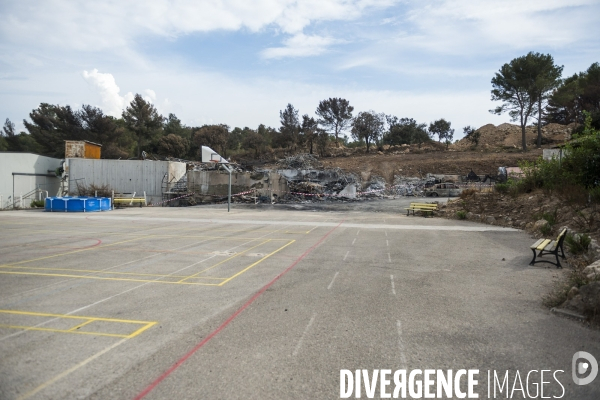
left=68, top=158, right=186, bottom=203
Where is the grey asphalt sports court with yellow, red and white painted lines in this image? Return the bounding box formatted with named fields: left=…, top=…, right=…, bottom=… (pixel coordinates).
left=0, top=199, right=600, bottom=399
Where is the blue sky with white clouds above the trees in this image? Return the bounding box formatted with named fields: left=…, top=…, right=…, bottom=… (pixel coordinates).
left=0, top=0, right=600, bottom=138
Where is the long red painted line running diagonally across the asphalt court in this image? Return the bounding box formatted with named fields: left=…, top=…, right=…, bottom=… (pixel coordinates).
left=134, top=221, right=344, bottom=400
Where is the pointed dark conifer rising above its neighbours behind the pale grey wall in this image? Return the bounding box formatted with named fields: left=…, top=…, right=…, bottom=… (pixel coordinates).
left=122, top=93, right=163, bottom=158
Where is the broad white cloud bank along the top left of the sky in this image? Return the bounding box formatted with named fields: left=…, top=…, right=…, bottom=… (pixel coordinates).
left=0, top=0, right=400, bottom=52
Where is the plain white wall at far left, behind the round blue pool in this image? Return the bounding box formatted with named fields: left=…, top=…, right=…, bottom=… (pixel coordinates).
left=0, top=152, right=61, bottom=208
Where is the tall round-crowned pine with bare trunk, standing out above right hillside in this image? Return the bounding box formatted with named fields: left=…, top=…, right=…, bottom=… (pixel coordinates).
left=490, top=52, right=562, bottom=151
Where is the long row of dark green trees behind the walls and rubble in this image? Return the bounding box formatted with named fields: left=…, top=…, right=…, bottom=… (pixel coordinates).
left=0, top=94, right=454, bottom=160
